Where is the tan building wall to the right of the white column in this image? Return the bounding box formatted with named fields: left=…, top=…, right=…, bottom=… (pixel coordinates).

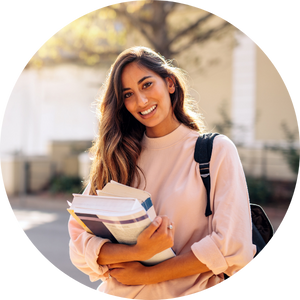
left=255, top=41, right=300, bottom=143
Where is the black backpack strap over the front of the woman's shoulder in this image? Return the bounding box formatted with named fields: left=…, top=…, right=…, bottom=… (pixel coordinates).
left=194, top=133, right=218, bottom=217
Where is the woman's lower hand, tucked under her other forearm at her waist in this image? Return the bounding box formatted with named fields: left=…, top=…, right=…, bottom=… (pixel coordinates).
left=104, top=262, right=150, bottom=285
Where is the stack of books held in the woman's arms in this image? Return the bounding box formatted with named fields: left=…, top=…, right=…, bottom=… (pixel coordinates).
left=67, top=181, right=175, bottom=265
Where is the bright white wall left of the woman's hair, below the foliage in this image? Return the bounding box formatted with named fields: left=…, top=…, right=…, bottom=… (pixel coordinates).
left=0, top=65, right=106, bottom=156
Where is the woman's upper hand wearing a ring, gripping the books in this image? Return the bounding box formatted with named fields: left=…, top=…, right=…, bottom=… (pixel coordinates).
left=134, top=216, right=175, bottom=260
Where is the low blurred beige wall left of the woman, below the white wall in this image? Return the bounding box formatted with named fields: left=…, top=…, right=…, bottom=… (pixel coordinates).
left=0, top=141, right=91, bottom=195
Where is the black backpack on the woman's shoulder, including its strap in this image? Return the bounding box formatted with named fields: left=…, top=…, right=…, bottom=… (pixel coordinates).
left=194, top=133, right=276, bottom=282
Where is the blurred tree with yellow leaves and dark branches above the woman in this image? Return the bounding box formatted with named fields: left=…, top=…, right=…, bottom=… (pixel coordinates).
left=24, top=0, right=232, bottom=66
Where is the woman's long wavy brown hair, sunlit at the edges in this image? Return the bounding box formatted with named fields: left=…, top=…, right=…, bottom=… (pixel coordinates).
left=85, top=47, right=205, bottom=195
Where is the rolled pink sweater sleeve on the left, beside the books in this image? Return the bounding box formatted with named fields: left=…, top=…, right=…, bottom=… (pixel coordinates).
left=68, top=185, right=110, bottom=282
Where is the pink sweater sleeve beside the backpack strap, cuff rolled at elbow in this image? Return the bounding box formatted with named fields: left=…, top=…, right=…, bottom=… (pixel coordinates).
left=191, top=135, right=256, bottom=278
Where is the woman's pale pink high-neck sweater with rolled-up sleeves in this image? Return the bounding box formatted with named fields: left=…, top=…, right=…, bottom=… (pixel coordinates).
left=69, top=125, right=256, bottom=300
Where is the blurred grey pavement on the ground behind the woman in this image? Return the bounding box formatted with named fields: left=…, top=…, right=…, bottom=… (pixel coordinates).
left=4, top=194, right=292, bottom=293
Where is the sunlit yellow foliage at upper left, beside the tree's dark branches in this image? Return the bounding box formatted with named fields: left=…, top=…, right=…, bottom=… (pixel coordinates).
left=23, top=5, right=126, bottom=67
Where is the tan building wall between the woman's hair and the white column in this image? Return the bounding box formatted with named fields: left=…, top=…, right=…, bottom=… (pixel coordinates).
left=173, top=4, right=235, bottom=131
